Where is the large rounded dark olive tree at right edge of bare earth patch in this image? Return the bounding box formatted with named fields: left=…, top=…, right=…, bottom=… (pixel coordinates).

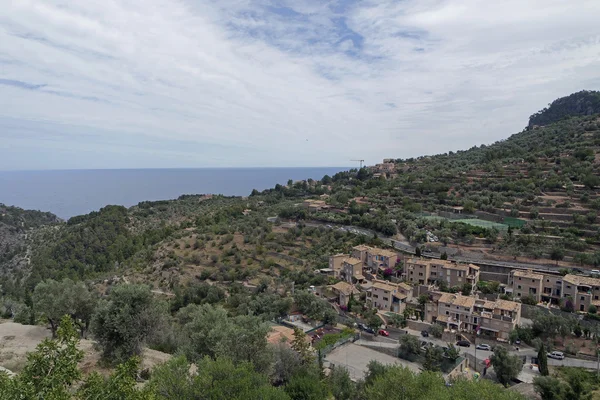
left=92, top=284, right=166, bottom=363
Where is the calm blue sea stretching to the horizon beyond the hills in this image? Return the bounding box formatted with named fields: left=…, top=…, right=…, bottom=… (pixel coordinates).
left=0, top=167, right=349, bottom=220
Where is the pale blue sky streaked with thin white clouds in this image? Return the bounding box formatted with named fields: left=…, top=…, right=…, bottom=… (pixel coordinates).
left=0, top=0, right=600, bottom=170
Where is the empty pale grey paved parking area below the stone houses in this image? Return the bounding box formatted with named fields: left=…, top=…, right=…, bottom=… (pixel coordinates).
left=325, top=343, right=420, bottom=380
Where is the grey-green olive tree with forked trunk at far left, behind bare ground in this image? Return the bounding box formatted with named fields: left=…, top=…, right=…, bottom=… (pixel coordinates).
left=32, top=279, right=96, bottom=337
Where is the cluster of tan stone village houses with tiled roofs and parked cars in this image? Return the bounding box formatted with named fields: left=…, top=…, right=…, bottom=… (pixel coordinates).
left=269, top=241, right=600, bottom=387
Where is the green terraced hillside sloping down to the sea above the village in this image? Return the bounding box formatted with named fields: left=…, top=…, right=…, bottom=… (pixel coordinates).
left=3, top=92, right=600, bottom=296
